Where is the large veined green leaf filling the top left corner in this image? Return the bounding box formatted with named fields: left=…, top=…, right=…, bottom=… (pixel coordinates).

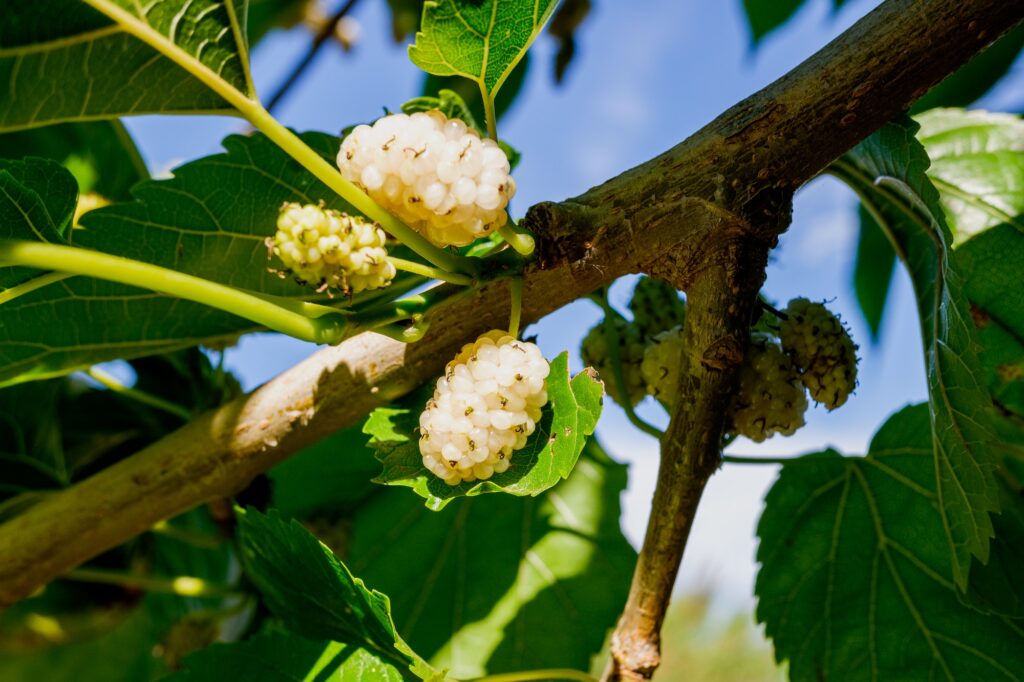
left=0, top=0, right=252, bottom=130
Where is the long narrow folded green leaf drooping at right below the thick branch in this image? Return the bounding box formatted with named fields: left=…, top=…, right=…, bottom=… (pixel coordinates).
left=834, top=119, right=998, bottom=588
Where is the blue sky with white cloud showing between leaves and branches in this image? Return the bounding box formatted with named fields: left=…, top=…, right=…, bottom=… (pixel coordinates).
left=119, top=0, right=1024, bottom=607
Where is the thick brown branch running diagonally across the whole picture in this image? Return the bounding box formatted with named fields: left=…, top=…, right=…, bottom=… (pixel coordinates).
left=0, top=0, right=1024, bottom=605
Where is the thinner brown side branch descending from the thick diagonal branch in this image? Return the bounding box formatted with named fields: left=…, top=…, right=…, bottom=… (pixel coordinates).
left=604, top=227, right=768, bottom=681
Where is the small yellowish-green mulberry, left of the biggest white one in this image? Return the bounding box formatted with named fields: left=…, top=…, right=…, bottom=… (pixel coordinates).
left=267, top=204, right=395, bottom=294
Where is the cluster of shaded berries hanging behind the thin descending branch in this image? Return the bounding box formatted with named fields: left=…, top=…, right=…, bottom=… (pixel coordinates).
left=582, top=279, right=857, bottom=442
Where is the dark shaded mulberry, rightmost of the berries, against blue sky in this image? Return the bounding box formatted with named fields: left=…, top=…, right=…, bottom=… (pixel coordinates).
left=778, top=298, right=857, bottom=410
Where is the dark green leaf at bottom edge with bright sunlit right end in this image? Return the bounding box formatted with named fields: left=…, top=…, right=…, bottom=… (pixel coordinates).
left=166, top=630, right=404, bottom=682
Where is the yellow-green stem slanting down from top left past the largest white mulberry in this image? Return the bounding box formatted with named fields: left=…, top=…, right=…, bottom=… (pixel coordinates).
left=84, top=0, right=478, bottom=274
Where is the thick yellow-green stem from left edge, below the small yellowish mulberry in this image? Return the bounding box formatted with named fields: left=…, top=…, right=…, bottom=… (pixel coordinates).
left=0, top=240, right=353, bottom=344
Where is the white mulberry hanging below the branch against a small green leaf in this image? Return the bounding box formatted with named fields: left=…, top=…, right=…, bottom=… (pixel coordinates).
left=420, top=331, right=551, bottom=485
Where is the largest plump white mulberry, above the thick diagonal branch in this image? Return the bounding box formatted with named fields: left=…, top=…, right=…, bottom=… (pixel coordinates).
left=338, top=111, right=515, bottom=246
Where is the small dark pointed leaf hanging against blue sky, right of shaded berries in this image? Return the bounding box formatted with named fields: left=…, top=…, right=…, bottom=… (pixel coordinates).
left=853, top=206, right=896, bottom=341
